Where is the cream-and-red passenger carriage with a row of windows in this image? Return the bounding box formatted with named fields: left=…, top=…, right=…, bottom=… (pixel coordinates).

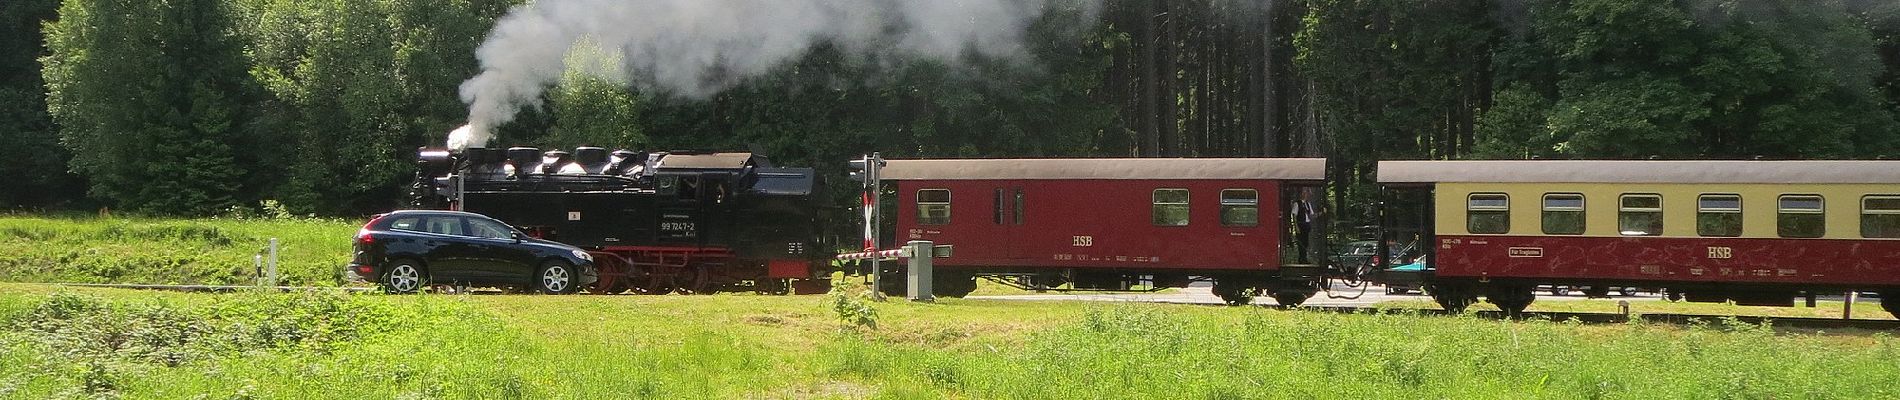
left=1379, top=161, right=1900, bottom=315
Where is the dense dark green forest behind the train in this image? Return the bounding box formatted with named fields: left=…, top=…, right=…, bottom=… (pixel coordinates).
left=11, top=0, right=1900, bottom=214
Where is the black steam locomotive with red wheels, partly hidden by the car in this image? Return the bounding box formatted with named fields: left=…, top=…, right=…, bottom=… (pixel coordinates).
left=410, top=148, right=834, bottom=294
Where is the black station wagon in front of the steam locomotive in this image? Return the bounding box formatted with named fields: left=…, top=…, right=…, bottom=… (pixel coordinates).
left=348, top=210, right=597, bottom=294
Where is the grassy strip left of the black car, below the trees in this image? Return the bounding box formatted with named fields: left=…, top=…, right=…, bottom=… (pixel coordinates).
left=0, top=216, right=363, bottom=286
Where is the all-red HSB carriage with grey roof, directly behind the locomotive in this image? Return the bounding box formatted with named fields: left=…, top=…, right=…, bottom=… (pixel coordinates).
left=880, top=159, right=1326, bottom=303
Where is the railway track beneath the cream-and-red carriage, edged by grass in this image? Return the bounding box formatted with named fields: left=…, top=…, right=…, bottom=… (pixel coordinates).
left=1275, top=305, right=1900, bottom=332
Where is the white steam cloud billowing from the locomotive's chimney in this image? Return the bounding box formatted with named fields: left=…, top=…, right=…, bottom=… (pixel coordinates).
left=450, top=0, right=1098, bottom=150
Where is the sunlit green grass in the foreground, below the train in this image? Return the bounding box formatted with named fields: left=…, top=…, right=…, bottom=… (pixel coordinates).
left=0, top=284, right=1900, bottom=398
